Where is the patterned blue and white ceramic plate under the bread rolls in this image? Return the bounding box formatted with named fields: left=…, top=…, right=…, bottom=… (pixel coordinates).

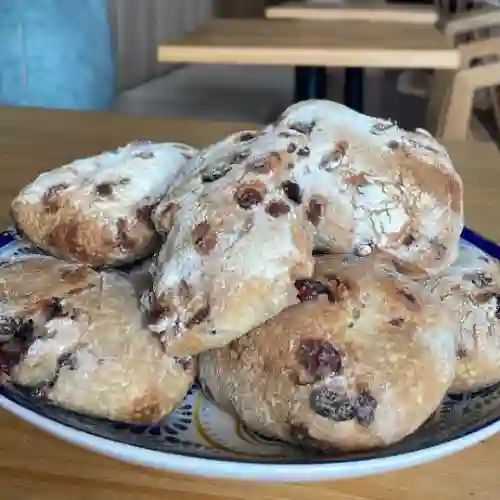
left=0, top=229, right=500, bottom=481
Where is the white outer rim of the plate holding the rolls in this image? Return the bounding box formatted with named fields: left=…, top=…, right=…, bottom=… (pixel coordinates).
left=0, top=227, right=500, bottom=482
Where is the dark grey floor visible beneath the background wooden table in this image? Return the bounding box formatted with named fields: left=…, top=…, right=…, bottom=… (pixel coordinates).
left=116, top=65, right=495, bottom=139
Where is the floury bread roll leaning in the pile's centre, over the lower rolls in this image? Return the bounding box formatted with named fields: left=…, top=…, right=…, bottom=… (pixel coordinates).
left=143, top=132, right=313, bottom=357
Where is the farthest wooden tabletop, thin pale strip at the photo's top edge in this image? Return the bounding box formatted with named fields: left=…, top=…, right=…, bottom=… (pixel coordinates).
left=265, top=2, right=439, bottom=25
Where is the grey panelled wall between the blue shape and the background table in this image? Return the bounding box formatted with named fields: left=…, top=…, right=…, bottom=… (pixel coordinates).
left=107, top=0, right=213, bottom=91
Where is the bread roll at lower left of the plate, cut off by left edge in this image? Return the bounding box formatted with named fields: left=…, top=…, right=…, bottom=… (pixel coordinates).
left=0, top=257, right=194, bottom=423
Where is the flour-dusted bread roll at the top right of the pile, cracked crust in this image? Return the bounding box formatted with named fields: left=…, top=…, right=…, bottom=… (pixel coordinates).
left=270, top=101, right=463, bottom=276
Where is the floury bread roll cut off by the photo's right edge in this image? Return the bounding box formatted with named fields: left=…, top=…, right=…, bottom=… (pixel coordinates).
left=426, top=243, right=500, bottom=392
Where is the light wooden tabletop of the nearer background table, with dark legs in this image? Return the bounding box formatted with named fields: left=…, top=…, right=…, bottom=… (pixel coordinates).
left=158, top=19, right=460, bottom=69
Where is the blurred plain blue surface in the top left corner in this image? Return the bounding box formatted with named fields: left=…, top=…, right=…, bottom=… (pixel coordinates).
left=0, top=0, right=114, bottom=109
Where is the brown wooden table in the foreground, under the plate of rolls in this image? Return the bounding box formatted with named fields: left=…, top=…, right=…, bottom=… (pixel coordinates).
left=0, top=104, right=500, bottom=500
